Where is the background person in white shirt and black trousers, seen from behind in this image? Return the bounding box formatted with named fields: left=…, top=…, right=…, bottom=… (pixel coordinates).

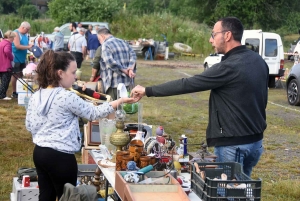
left=68, top=27, right=87, bottom=69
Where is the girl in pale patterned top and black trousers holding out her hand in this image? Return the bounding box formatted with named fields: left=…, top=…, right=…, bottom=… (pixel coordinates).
left=25, top=50, right=136, bottom=201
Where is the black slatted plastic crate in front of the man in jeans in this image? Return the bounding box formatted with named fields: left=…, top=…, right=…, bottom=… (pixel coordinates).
left=191, top=162, right=261, bottom=201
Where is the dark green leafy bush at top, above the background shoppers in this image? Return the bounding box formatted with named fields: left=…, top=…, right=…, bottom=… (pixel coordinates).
left=48, top=0, right=122, bottom=24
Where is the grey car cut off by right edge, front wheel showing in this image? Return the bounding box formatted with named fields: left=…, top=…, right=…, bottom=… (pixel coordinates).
left=286, top=64, right=300, bottom=105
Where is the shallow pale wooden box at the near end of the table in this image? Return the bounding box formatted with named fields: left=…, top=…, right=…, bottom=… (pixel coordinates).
left=115, top=171, right=189, bottom=201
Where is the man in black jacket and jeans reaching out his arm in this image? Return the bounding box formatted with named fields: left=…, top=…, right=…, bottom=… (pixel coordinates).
left=131, top=17, right=269, bottom=176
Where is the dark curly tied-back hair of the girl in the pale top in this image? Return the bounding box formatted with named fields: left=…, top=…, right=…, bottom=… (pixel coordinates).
left=36, top=50, right=75, bottom=89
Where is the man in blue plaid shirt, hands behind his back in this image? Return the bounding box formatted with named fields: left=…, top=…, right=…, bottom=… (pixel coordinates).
left=97, top=27, right=136, bottom=100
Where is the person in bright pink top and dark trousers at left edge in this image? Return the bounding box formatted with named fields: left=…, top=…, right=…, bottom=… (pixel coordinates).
left=0, top=30, right=16, bottom=100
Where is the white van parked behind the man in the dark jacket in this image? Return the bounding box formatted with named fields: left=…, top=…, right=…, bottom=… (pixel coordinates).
left=204, top=30, right=284, bottom=88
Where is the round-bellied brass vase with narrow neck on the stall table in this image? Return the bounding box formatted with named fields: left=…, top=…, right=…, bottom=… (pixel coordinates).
left=109, top=120, right=130, bottom=151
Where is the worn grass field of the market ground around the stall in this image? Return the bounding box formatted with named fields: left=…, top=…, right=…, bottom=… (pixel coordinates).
left=0, top=59, right=300, bottom=201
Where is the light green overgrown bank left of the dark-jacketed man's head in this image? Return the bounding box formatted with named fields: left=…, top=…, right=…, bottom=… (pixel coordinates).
left=110, top=12, right=212, bottom=55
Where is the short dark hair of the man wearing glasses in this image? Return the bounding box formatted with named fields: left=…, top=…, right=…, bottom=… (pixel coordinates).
left=218, top=17, right=244, bottom=42
